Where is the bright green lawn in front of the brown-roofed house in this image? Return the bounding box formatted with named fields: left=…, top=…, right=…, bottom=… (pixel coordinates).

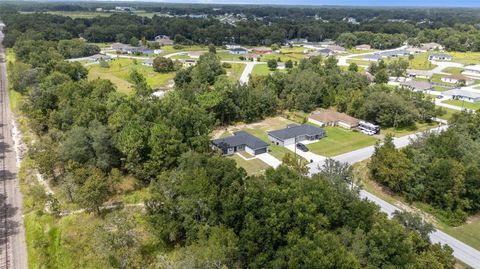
left=307, top=127, right=377, bottom=157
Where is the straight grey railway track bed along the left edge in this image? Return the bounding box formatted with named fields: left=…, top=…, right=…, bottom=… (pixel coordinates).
left=0, top=27, right=28, bottom=269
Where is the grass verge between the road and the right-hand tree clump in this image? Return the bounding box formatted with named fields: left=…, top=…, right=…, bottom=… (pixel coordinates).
left=353, top=160, right=480, bottom=250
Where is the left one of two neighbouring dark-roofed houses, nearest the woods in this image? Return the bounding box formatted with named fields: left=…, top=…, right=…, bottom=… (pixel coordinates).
left=212, top=131, right=268, bottom=155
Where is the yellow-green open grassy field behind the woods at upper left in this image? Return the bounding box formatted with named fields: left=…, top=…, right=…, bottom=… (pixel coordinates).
left=88, top=59, right=175, bottom=94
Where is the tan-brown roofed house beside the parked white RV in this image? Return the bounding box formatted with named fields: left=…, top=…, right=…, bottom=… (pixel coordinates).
left=308, top=110, right=360, bottom=129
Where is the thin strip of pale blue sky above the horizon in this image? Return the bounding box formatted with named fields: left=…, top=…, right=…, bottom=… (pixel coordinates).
left=104, top=0, right=480, bottom=7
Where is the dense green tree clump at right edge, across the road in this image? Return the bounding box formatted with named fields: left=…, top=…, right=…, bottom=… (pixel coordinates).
left=370, top=113, right=480, bottom=225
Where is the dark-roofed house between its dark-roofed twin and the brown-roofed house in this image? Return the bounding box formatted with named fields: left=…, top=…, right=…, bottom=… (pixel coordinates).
left=268, top=124, right=325, bottom=146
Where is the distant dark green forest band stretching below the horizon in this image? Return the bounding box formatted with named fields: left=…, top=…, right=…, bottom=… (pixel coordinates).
left=1, top=4, right=480, bottom=51
